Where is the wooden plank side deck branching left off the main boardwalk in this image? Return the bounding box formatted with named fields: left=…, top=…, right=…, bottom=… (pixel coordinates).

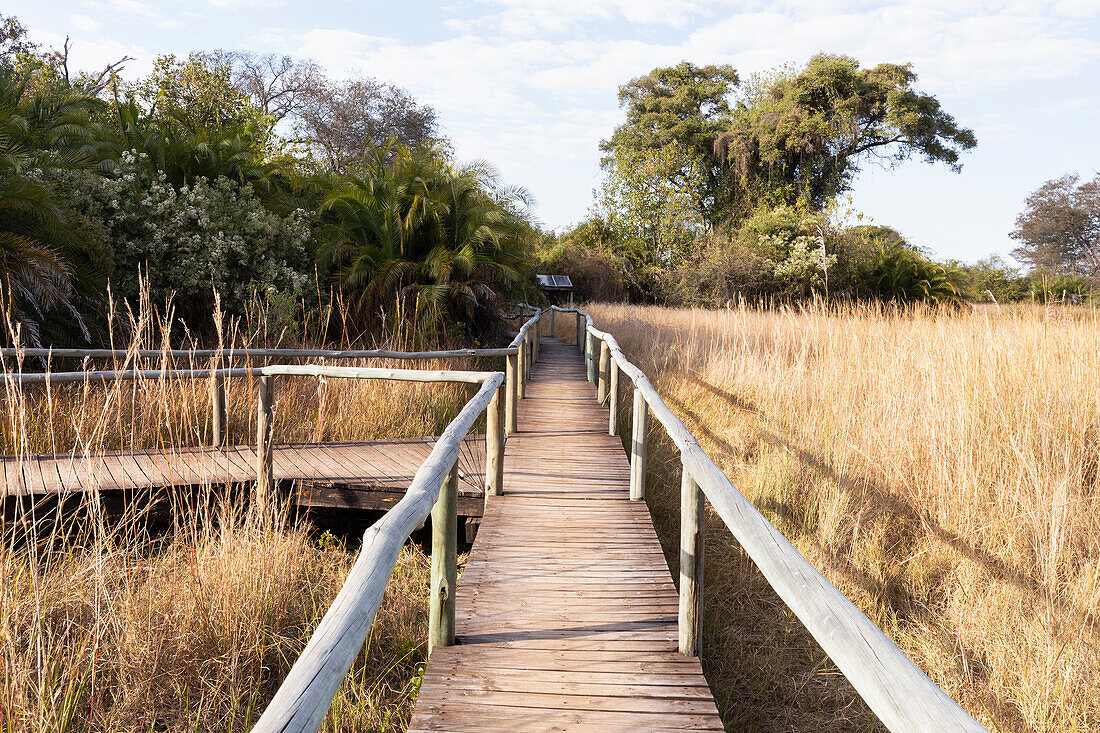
left=0, top=436, right=485, bottom=516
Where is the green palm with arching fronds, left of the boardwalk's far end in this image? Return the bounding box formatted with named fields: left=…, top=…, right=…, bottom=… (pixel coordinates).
left=319, top=142, right=529, bottom=332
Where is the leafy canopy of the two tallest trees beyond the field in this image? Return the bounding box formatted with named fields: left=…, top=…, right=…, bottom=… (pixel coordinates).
left=602, top=54, right=977, bottom=250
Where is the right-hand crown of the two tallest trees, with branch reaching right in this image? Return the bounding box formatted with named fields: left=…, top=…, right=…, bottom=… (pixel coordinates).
left=715, top=54, right=977, bottom=212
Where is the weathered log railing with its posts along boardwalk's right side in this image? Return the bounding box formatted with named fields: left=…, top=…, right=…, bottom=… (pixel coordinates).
left=551, top=307, right=986, bottom=733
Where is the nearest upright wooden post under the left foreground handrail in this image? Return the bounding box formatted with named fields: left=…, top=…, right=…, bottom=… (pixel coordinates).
left=428, top=461, right=459, bottom=656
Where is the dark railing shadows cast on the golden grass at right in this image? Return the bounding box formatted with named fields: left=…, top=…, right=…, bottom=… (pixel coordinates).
left=666, top=375, right=1095, bottom=731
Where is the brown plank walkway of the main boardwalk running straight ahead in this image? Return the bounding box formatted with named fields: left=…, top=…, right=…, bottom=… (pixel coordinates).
left=409, top=338, right=722, bottom=731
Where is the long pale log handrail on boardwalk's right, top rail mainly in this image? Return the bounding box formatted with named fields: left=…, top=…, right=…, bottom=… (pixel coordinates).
left=553, top=306, right=986, bottom=733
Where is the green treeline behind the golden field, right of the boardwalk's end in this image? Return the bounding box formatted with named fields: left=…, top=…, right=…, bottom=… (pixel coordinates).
left=538, top=54, right=1100, bottom=306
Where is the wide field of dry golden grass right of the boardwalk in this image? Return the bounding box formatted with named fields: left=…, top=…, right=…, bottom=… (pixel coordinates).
left=591, top=306, right=1100, bottom=731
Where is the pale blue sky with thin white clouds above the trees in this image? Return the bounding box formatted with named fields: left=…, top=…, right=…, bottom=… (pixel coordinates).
left=3, top=0, right=1100, bottom=262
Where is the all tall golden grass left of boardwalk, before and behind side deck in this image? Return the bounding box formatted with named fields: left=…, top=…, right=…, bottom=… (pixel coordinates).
left=0, top=301, right=481, bottom=733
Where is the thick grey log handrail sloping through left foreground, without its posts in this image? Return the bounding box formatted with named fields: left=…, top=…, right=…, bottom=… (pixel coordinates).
left=252, top=372, right=504, bottom=733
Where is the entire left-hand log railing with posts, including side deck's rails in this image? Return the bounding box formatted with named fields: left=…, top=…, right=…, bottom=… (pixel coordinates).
left=0, top=309, right=542, bottom=732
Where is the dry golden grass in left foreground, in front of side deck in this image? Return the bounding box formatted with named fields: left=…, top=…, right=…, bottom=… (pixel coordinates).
left=0, top=521, right=428, bottom=732
